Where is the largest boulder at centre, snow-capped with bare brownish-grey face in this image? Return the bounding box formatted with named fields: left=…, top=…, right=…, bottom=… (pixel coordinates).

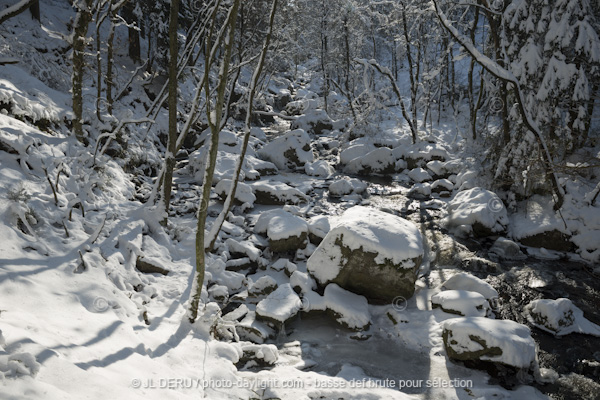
left=307, top=206, right=423, bottom=302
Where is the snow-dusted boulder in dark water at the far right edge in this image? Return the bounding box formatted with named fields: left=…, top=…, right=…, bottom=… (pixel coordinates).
left=525, top=298, right=600, bottom=336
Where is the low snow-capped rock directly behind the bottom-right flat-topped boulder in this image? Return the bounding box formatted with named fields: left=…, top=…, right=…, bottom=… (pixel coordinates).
left=431, top=290, right=489, bottom=317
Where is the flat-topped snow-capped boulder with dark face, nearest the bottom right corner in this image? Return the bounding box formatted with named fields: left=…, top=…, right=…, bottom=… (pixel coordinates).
left=442, top=317, right=536, bottom=370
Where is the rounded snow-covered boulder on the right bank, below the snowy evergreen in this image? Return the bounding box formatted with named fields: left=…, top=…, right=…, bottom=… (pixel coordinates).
left=445, top=187, right=508, bottom=237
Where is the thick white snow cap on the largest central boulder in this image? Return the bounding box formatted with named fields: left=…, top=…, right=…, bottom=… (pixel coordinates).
left=307, top=206, right=423, bottom=283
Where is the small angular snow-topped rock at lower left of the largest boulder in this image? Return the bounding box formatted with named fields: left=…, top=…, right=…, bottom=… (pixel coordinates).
left=256, top=283, right=302, bottom=324
